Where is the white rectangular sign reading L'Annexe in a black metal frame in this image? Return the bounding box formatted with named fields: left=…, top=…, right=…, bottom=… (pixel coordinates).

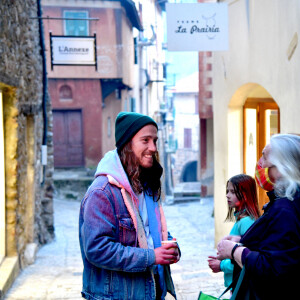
left=51, top=36, right=96, bottom=65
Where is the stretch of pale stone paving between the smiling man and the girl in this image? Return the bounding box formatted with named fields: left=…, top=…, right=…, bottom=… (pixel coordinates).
left=164, top=198, right=229, bottom=300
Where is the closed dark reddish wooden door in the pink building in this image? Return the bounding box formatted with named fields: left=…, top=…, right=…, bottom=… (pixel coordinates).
left=53, top=110, right=84, bottom=167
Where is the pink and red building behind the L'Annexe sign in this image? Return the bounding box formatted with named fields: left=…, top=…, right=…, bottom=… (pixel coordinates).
left=41, top=0, right=141, bottom=169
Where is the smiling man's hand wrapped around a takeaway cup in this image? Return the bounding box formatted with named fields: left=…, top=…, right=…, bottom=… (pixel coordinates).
left=154, top=243, right=180, bottom=265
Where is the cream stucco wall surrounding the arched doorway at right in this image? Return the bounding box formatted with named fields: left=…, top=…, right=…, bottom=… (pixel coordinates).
left=213, top=0, right=300, bottom=242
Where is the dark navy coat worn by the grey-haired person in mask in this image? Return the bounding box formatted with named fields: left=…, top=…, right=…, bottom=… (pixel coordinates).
left=235, top=189, right=300, bottom=299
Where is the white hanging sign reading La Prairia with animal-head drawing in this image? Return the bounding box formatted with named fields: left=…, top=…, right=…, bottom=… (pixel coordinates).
left=166, top=3, right=228, bottom=51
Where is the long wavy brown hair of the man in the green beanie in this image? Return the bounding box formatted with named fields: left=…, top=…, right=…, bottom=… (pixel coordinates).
left=118, top=141, right=163, bottom=201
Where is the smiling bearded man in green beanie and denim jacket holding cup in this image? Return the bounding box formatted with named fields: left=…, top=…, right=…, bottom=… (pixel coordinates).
left=79, top=112, right=180, bottom=300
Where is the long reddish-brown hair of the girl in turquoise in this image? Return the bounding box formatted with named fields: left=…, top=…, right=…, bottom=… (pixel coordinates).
left=225, top=174, right=260, bottom=221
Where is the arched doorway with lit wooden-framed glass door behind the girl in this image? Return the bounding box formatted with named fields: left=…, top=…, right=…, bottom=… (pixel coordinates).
left=228, top=83, right=280, bottom=208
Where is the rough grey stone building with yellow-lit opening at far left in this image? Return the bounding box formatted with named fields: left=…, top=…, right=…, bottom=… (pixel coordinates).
left=0, top=0, right=54, bottom=299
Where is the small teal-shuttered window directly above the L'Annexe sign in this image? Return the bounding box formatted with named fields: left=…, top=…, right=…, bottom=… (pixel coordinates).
left=64, top=11, right=89, bottom=36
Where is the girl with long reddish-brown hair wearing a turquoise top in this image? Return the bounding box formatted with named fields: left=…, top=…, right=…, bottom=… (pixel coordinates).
left=208, top=174, right=260, bottom=287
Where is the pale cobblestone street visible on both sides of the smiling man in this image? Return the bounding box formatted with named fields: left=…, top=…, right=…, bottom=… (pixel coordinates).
left=5, top=198, right=229, bottom=300
